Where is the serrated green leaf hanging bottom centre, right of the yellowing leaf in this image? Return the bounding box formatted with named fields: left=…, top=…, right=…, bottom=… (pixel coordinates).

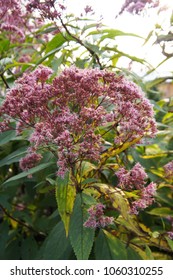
left=69, top=194, right=94, bottom=260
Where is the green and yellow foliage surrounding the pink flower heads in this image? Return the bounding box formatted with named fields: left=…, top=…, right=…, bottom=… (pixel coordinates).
left=0, top=1, right=173, bottom=260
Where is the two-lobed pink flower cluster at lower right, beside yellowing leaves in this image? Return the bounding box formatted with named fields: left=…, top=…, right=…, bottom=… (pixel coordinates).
left=116, top=163, right=156, bottom=214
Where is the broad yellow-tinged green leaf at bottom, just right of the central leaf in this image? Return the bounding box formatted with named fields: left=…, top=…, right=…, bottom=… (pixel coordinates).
left=95, top=230, right=141, bottom=260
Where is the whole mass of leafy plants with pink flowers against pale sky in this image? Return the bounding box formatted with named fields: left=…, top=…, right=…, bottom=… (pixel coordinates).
left=0, top=0, right=173, bottom=260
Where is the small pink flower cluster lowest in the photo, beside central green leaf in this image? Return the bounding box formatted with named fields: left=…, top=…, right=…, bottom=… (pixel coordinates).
left=84, top=203, right=114, bottom=228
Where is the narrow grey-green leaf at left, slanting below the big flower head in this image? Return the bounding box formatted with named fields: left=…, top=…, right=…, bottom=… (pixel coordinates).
left=3, top=162, right=54, bottom=186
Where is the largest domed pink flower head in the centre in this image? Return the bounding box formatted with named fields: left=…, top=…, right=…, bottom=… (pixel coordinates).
left=0, top=65, right=157, bottom=176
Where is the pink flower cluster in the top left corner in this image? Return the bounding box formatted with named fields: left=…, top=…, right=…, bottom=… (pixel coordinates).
left=0, top=0, right=55, bottom=43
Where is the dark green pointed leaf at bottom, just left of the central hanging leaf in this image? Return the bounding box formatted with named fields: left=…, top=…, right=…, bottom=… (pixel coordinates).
left=38, top=222, right=72, bottom=260
